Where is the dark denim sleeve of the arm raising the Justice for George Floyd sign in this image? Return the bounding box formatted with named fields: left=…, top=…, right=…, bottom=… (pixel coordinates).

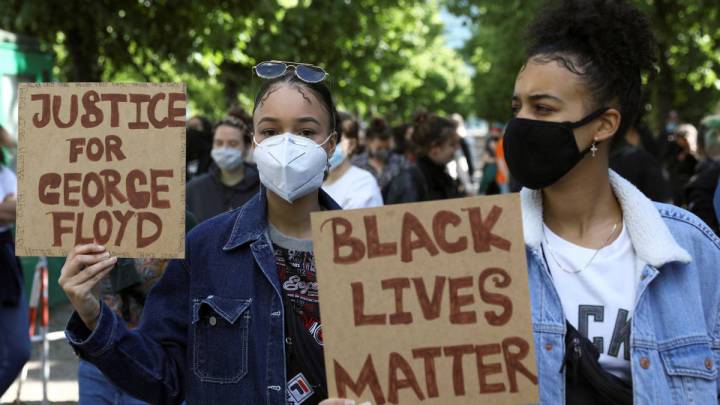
left=65, top=260, right=189, bottom=405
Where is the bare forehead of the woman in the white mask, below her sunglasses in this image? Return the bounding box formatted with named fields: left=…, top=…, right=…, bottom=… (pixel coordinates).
left=253, top=84, right=328, bottom=124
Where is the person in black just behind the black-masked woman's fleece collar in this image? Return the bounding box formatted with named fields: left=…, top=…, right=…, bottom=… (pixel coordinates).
left=610, top=120, right=672, bottom=202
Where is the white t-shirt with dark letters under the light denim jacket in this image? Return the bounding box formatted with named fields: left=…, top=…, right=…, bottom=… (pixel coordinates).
left=543, top=224, right=641, bottom=381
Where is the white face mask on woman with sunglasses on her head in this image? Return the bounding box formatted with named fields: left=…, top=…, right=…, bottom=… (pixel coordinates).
left=253, top=132, right=333, bottom=203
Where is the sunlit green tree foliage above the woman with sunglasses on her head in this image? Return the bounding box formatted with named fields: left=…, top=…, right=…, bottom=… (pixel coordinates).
left=0, top=0, right=471, bottom=119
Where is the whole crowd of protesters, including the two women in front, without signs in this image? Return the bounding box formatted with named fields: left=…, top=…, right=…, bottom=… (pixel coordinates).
left=0, top=0, right=720, bottom=405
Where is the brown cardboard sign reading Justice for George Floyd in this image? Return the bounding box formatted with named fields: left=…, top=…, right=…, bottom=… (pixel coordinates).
left=16, top=83, right=186, bottom=258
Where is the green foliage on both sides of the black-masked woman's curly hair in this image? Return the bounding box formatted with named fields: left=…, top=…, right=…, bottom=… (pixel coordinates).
left=448, top=0, right=720, bottom=126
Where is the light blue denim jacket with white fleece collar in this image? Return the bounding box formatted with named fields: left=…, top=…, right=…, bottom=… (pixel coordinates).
left=521, top=172, right=720, bottom=405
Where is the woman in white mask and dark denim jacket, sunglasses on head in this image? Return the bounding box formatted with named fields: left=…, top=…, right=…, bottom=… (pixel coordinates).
left=60, top=62, right=340, bottom=404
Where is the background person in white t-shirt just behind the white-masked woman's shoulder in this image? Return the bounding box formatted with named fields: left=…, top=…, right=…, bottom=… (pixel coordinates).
left=322, top=112, right=383, bottom=209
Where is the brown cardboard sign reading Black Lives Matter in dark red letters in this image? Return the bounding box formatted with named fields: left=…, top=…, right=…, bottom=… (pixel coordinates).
left=312, top=195, right=539, bottom=405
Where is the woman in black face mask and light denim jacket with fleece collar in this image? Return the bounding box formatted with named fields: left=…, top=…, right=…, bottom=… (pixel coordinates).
left=504, top=0, right=720, bottom=404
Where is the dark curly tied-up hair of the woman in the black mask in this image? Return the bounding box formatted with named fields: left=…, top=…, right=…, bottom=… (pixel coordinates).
left=526, top=0, right=657, bottom=136
